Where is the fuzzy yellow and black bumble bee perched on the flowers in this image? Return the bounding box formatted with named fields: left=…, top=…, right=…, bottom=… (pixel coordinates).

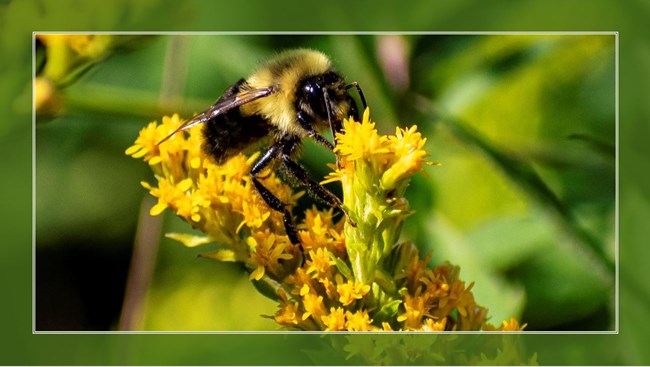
left=158, top=49, right=366, bottom=244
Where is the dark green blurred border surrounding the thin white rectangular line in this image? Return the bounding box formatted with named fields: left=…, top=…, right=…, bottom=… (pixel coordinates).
left=0, top=0, right=650, bottom=365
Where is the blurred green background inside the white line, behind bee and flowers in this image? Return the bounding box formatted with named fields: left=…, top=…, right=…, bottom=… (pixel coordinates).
left=36, top=34, right=616, bottom=331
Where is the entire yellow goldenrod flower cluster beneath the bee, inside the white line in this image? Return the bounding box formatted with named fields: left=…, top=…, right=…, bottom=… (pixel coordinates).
left=126, top=111, right=521, bottom=331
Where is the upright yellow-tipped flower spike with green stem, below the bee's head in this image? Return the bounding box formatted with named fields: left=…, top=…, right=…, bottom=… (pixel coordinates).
left=324, top=109, right=436, bottom=283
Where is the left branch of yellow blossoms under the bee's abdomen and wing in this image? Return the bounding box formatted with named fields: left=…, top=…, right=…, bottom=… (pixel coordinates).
left=126, top=115, right=299, bottom=280
